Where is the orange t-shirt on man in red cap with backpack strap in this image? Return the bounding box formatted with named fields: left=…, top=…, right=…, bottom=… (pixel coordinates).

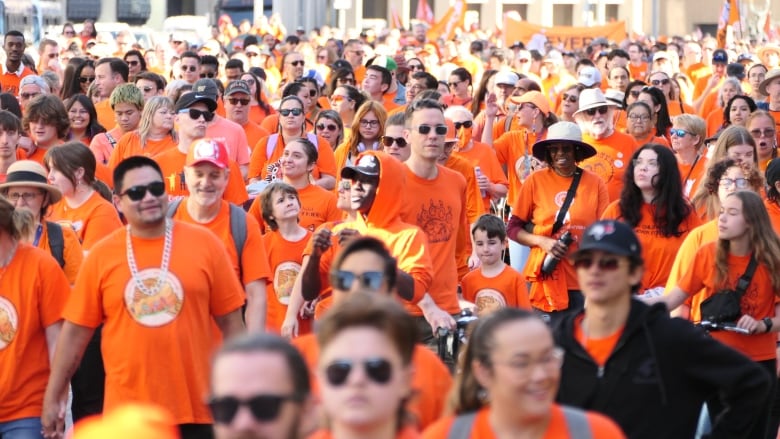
left=173, top=197, right=271, bottom=285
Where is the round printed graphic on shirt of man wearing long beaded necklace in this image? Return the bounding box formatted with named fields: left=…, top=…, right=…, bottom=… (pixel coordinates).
left=125, top=268, right=184, bottom=327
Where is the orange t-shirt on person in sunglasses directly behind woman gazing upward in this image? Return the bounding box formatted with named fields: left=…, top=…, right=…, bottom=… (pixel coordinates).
left=247, top=134, right=338, bottom=181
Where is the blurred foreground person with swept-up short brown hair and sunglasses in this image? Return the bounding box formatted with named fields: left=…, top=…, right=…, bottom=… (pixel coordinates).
left=311, top=291, right=419, bottom=439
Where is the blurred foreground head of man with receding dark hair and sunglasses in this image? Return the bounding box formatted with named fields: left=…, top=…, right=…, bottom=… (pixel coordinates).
left=208, top=334, right=313, bottom=439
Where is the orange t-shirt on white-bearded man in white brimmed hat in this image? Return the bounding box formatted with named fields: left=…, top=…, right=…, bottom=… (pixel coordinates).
left=581, top=131, right=639, bottom=201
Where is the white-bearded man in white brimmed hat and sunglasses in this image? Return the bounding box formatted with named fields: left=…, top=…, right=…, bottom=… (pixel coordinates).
left=574, top=88, right=638, bottom=202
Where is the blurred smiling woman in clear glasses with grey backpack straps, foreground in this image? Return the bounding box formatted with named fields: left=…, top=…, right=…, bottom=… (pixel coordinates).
left=422, top=308, right=625, bottom=439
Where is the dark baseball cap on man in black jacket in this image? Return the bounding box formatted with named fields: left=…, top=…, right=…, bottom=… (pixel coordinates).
left=572, top=220, right=642, bottom=260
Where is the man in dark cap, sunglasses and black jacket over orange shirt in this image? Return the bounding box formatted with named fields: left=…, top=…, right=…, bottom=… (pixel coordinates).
left=554, top=220, right=774, bottom=439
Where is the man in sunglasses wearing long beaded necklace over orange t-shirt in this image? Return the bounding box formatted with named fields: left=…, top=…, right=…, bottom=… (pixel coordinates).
left=42, top=156, right=244, bottom=438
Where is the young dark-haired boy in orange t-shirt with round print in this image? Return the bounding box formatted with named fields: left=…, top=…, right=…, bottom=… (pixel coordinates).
left=461, top=215, right=531, bottom=317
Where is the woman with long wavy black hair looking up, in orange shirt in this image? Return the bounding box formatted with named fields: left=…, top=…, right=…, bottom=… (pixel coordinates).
left=602, top=146, right=700, bottom=296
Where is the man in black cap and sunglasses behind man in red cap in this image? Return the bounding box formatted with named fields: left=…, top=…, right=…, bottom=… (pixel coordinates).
left=152, top=92, right=249, bottom=206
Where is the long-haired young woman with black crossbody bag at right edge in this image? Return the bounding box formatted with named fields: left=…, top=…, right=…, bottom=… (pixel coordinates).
left=662, top=191, right=780, bottom=439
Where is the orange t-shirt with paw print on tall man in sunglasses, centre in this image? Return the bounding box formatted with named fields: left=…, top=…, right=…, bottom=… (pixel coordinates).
left=399, top=166, right=471, bottom=316
